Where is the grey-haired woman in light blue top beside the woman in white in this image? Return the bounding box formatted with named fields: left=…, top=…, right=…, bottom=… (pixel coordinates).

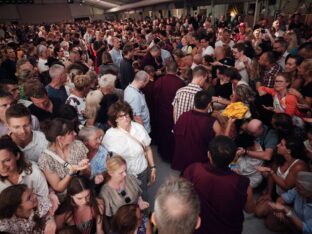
left=78, top=126, right=108, bottom=184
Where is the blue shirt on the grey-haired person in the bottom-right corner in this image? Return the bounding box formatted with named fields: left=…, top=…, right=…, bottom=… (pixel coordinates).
left=282, top=188, right=312, bottom=234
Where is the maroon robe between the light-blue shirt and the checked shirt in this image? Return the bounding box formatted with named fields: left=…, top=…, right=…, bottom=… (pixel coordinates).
left=154, top=74, right=185, bottom=161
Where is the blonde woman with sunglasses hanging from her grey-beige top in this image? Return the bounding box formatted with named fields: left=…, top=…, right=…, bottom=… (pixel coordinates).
left=100, top=155, right=149, bottom=217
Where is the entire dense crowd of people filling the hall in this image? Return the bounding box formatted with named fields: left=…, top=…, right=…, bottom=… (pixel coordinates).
left=0, top=11, right=312, bottom=234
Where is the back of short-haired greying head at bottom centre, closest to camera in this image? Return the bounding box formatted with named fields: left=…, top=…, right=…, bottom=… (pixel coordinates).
left=154, top=177, right=200, bottom=234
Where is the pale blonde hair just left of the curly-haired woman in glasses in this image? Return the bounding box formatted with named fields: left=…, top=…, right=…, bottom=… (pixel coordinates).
left=85, top=90, right=103, bottom=119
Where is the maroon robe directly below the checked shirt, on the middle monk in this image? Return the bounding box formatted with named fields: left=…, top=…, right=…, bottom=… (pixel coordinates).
left=171, top=110, right=215, bottom=172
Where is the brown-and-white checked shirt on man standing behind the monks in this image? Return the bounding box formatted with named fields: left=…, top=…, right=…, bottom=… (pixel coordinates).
left=172, top=83, right=202, bottom=123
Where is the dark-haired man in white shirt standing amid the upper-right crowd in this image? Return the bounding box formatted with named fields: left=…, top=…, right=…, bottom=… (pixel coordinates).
left=232, top=43, right=251, bottom=84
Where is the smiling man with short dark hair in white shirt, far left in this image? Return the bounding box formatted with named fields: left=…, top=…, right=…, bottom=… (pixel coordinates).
left=5, top=104, right=49, bottom=162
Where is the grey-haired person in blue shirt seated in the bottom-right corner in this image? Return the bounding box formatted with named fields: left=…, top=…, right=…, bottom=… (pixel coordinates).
left=266, top=172, right=312, bottom=233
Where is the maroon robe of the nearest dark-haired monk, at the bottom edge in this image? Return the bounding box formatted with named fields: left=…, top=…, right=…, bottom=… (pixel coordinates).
left=183, top=163, right=249, bottom=234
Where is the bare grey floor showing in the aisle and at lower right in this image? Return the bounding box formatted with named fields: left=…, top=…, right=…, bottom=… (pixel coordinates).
left=148, top=146, right=273, bottom=234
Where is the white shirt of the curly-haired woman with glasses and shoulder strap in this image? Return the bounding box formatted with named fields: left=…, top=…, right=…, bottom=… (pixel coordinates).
left=103, top=122, right=151, bottom=175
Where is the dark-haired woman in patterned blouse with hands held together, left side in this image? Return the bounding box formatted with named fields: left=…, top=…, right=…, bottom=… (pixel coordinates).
left=38, top=118, right=90, bottom=201
